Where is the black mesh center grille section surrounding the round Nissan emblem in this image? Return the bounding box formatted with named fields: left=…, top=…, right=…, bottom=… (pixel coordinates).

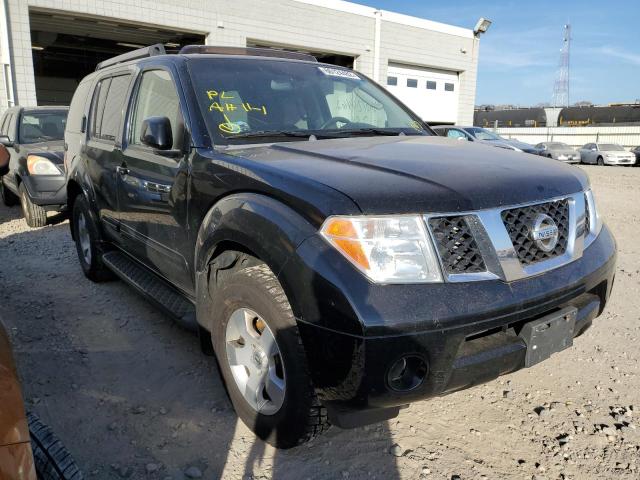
left=502, top=198, right=569, bottom=265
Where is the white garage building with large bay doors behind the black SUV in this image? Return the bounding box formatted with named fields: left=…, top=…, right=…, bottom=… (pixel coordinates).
left=0, top=0, right=479, bottom=124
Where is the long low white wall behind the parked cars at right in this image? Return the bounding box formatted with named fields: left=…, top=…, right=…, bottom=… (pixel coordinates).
left=494, top=126, right=640, bottom=149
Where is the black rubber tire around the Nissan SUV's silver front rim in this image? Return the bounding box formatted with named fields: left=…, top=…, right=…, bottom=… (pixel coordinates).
left=209, top=262, right=329, bottom=449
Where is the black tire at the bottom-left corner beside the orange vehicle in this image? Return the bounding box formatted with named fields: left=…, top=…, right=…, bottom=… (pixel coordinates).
left=27, top=413, right=84, bottom=480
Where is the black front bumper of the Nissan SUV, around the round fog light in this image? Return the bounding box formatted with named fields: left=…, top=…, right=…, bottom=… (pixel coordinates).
left=280, top=226, right=616, bottom=427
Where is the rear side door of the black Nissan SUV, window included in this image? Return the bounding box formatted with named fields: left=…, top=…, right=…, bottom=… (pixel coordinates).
left=85, top=72, right=132, bottom=241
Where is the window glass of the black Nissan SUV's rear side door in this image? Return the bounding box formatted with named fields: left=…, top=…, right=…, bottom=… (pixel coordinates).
left=91, top=75, right=131, bottom=142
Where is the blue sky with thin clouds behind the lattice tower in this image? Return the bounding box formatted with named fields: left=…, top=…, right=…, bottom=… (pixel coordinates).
left=355, top=0, right=640, bottom=106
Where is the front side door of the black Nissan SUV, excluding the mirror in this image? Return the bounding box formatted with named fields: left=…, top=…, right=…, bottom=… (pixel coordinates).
left=118, top=69, right=193, bottom=292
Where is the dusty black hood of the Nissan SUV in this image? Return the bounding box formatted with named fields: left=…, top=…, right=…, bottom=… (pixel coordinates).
left=230, top=136, right=588, bottom=214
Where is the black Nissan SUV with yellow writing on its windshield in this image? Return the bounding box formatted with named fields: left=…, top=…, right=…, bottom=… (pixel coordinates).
left=65, top=46, right=616, bottom=448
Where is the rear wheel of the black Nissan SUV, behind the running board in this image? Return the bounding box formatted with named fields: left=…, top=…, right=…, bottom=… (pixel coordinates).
left=71, top=195, right=113, bottom=282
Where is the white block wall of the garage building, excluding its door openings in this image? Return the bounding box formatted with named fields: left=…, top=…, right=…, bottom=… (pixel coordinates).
left=0, top=0, right=478, bottom=124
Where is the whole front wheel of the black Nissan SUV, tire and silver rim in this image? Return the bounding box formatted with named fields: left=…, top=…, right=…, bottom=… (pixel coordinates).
left=210, top=264, right=329, bottom=448
